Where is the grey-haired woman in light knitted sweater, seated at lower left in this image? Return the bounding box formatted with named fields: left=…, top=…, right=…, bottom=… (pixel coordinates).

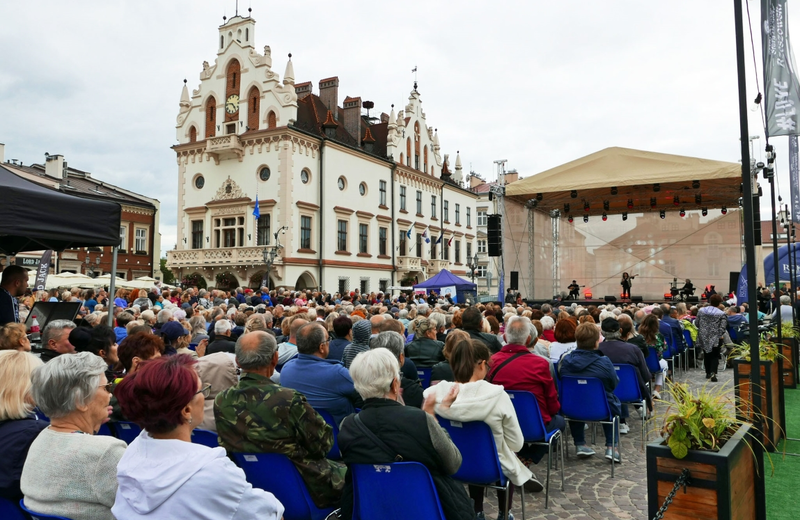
left=20, top=352, right=126, bottom=520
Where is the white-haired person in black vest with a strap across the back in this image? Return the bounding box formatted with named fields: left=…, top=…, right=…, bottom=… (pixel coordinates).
left=339, top=348, right=475, bottom=520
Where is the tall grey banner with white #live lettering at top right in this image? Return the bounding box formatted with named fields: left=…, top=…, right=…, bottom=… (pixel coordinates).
left=761, top=0, right=800, bottom=137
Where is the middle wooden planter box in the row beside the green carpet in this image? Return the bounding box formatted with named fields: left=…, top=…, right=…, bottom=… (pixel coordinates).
left=733, top=359, right=786, bottom=451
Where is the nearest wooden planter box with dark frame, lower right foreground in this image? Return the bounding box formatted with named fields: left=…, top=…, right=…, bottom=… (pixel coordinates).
left=647, top=424, right=764, bottom=520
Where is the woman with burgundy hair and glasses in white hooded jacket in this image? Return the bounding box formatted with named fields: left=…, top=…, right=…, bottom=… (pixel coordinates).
left=111, top=354, right=284, bottom=520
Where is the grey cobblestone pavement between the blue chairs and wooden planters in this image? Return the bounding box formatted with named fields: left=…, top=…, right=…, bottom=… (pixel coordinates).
left=484, top=362, right=733, bottom=520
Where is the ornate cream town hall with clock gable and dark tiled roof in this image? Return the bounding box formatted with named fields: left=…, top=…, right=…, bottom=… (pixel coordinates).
left=168, top=16, right=476, bottom=292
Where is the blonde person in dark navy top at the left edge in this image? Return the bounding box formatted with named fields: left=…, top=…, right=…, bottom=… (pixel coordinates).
left=0, top=352, right=45, bottom=503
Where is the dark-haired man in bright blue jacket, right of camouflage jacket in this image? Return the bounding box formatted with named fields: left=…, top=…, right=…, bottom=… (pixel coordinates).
left=281, top=322, right=369, bottom=424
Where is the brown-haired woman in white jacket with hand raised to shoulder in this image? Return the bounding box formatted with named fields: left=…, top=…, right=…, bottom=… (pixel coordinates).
left=424, top=340, right=533, bottom=519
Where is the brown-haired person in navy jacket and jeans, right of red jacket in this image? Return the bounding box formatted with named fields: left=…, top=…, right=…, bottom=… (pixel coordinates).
left=558, top=322, right=620, bottom=463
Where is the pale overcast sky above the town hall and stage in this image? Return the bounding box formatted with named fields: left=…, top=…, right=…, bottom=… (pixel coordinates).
left=0, top=0, right=800, bottom=251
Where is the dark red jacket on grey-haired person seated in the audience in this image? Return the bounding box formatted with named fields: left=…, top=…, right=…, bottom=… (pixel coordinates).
left=489, top=345, right=561, bottom=425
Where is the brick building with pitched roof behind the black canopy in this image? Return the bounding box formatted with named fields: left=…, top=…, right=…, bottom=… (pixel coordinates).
left=0, top=145, right=162, bottom=280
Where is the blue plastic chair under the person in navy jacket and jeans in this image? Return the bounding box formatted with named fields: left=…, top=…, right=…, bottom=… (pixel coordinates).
left=561, top=376, right=619, bottom=478
